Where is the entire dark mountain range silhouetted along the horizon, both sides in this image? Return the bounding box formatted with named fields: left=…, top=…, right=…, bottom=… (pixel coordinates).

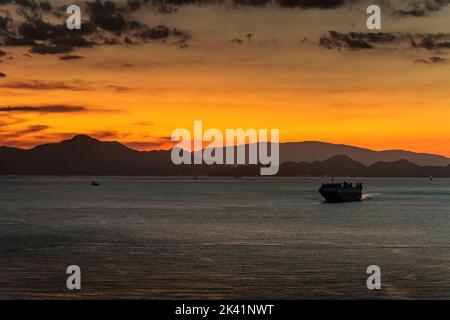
left=0, top=135, right=450, bottom=177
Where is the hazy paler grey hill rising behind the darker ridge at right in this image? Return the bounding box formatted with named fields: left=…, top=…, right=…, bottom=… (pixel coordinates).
left=280, top=141, right=450, bottom=166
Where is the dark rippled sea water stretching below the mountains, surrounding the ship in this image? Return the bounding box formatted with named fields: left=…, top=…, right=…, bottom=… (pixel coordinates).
left=0, top=177, right=450, bottom=299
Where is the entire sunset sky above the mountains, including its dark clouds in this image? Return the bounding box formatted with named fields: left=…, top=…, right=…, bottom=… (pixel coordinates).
left=0, top=0, right=450, bottom=156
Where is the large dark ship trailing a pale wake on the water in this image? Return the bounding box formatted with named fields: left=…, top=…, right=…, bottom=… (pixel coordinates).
left=319, top=182, right=363, bottom=202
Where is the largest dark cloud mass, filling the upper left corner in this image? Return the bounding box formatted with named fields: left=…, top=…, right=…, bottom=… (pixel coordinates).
left=0, top=0, right=192, bottom=54
